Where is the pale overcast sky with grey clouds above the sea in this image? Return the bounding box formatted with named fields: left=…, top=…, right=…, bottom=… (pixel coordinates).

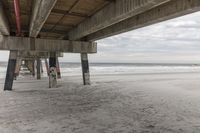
left=0, top=12, right=200, bottom=63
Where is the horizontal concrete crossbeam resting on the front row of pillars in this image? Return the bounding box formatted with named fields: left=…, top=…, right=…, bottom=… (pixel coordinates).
left=0, top=36, right=97, bottom=53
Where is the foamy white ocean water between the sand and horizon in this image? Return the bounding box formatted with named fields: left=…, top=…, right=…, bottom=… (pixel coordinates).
left=0, top=62, right=200, bottom=78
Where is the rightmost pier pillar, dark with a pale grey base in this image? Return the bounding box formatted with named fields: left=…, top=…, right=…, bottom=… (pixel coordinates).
left=81, top=53, right=90, bottom=85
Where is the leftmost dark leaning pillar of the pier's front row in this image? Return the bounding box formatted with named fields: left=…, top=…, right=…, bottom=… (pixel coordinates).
left=4, top=51, right=17, bottom=91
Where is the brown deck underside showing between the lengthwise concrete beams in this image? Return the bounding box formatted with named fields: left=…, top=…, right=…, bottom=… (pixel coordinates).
left=2, top=0, right=111, bottom=39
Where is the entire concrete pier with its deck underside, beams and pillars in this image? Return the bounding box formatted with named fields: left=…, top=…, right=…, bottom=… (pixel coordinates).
left=0, top=0, right=200, bottom=90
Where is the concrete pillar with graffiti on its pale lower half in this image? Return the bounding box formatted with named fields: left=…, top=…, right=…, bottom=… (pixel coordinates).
left=49, top=53, right=57, bottom=88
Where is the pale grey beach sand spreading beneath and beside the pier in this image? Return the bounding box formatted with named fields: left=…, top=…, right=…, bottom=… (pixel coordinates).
left=0, top=73, right=200, bottom=133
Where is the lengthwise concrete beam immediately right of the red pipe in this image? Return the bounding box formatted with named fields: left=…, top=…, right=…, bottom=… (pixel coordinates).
left=29, top=0, right=57, bottom=37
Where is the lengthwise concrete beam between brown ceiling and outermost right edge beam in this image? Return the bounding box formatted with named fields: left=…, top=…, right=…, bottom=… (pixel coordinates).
left=68, top=0, right=169, bottom=40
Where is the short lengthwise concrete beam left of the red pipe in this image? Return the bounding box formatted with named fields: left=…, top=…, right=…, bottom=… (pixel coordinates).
left=0, top=1, right=10, bottom=35
